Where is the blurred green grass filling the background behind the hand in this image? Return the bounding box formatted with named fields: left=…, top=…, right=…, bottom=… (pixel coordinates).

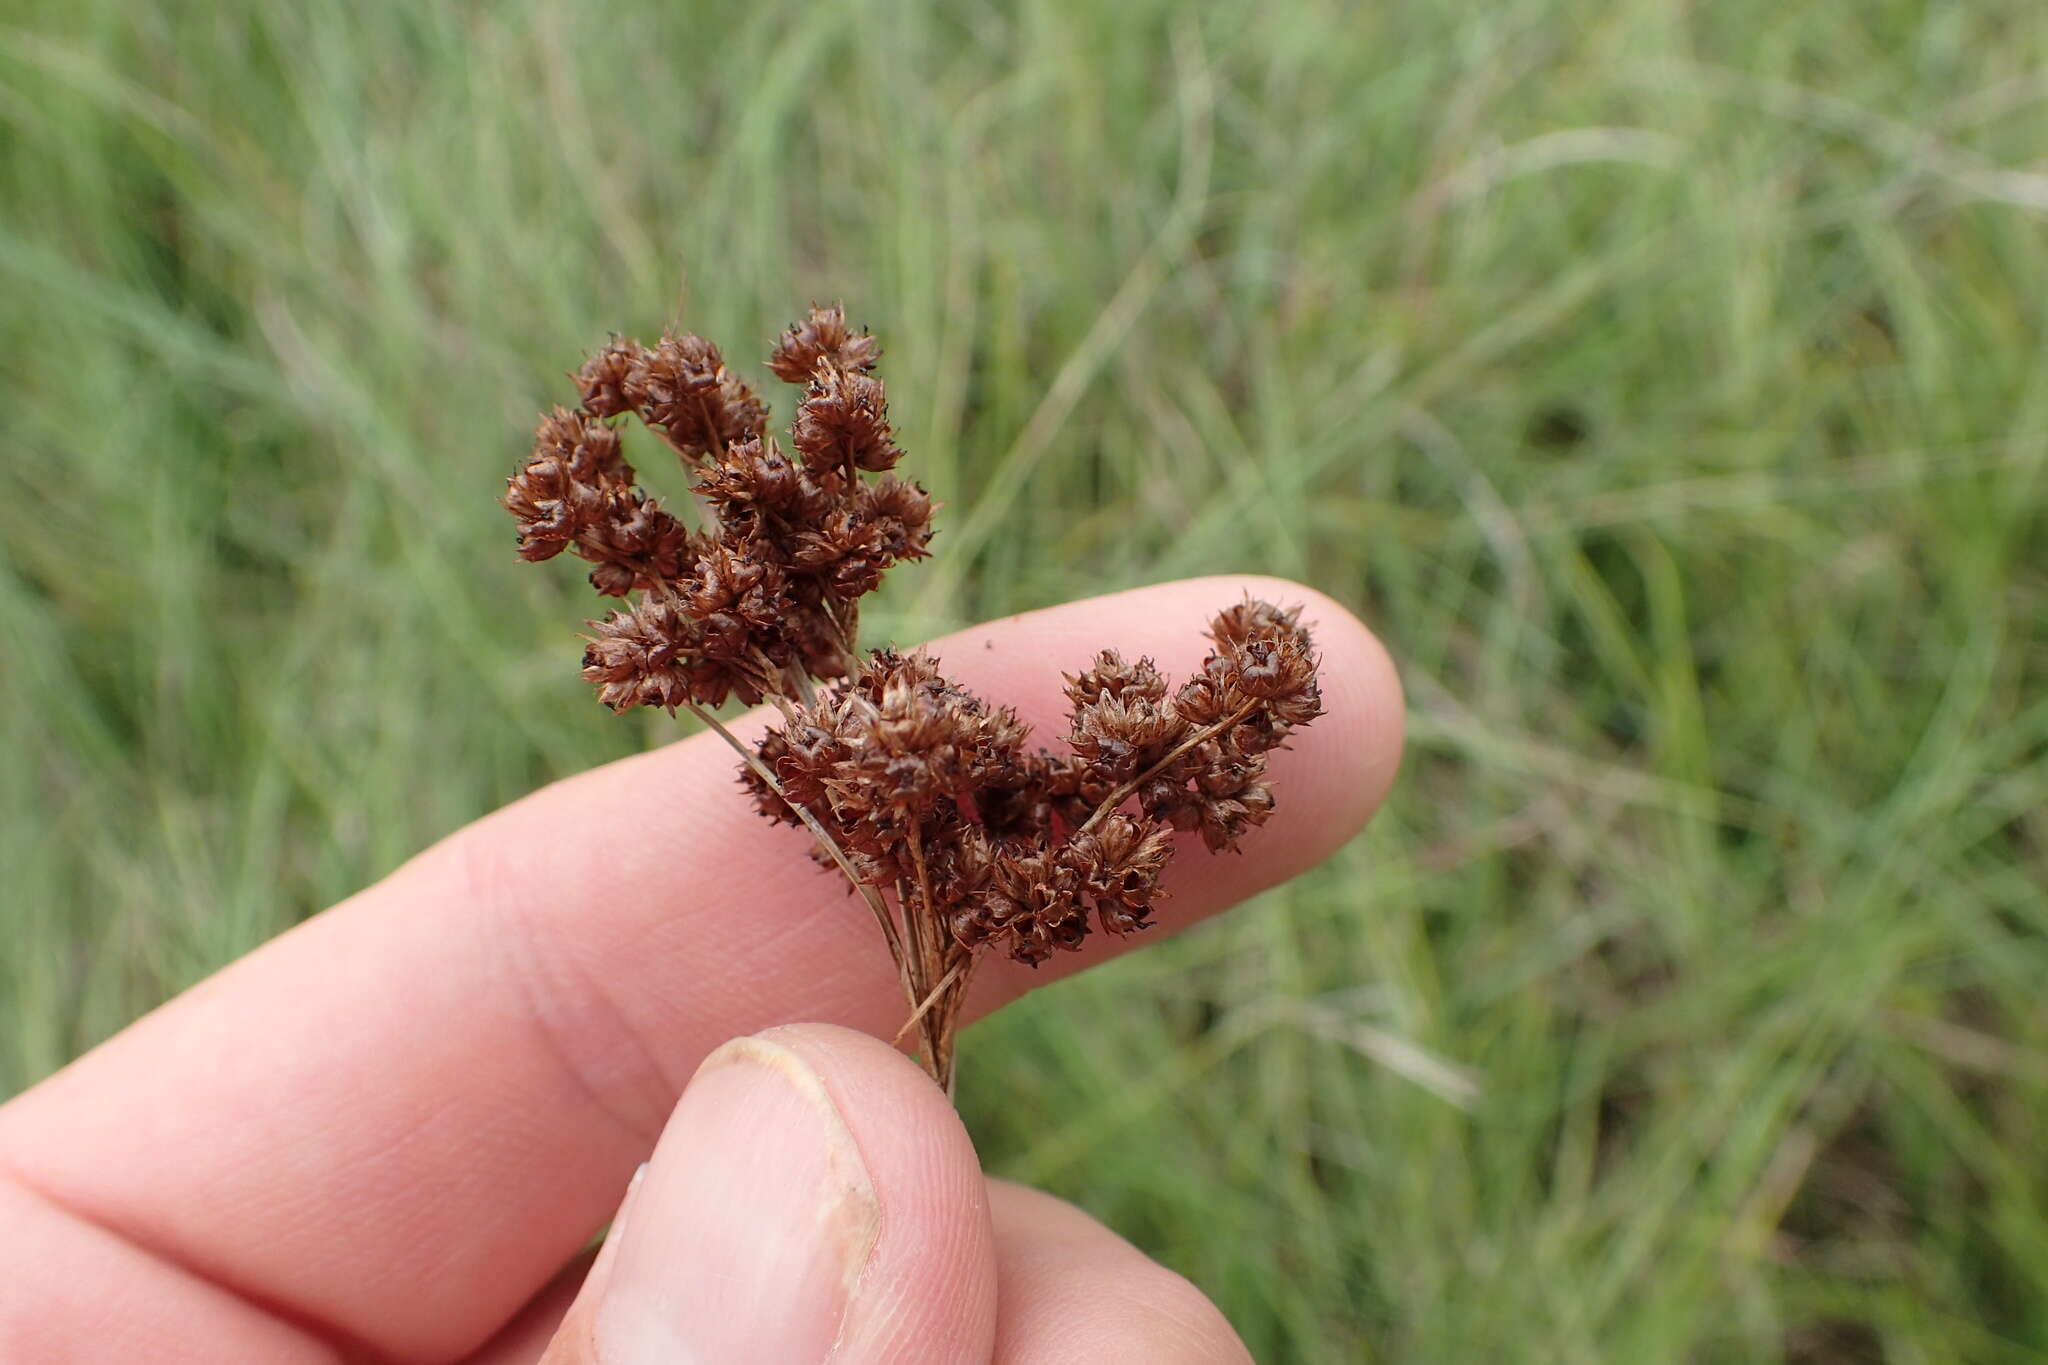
left=0, top=0, right=2048, bottom=1363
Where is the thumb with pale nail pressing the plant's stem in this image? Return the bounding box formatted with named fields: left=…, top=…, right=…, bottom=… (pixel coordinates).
left=543, top=1023, right=995, bottom=1365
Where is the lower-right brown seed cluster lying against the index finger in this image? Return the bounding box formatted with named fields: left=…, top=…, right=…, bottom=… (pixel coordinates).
left=741, top=602, right=1321, bottom=966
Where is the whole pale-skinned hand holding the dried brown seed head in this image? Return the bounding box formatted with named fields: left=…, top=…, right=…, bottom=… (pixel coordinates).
left=0, top=577, right=1401, bottom=1365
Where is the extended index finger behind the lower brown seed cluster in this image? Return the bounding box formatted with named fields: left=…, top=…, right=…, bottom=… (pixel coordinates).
left=0, top=577, right=1401, bottom=1361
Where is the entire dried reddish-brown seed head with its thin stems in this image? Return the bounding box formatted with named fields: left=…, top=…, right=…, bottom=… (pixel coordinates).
left=504, top=307, right=1321, bottom=1089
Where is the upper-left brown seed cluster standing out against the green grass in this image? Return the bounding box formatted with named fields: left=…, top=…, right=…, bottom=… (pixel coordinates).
left=504, top=307, right=932, bottom=710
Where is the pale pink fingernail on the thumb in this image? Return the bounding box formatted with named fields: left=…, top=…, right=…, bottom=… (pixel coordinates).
left=596, top=1038, right=881, bottom=1365
